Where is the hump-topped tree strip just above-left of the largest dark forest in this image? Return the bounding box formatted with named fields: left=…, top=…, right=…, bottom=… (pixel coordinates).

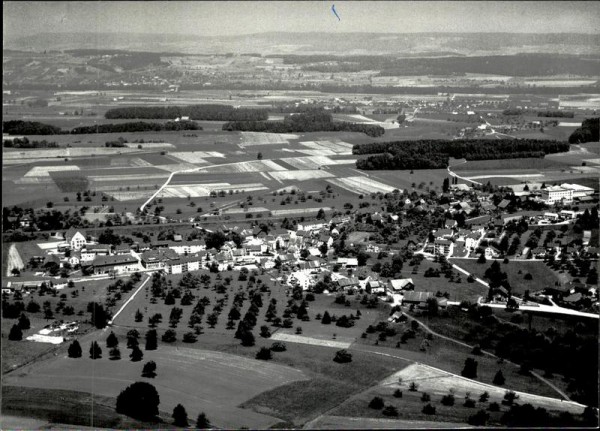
left=223, top=111, right=385, bottom=138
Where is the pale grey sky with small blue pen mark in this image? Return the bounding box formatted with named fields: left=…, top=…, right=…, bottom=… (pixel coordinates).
left=3, top=0, right=600, bottom=39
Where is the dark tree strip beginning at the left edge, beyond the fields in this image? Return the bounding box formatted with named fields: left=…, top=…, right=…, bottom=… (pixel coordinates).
left=2, top=120, right=202, bottom=136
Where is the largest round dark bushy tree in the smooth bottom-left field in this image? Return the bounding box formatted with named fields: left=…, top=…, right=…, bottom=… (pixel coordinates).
left=117, top=382, right=160, bottom=421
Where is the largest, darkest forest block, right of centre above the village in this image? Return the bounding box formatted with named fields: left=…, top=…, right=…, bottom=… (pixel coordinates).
left=352, top=139, right=569, bottom=170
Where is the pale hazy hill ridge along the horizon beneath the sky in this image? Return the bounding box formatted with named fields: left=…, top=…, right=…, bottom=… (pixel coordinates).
left=4, top=32, right=600, bottom=55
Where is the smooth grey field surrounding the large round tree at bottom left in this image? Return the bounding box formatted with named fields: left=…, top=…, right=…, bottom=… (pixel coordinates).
left=3, top=343, right=306, bottom=429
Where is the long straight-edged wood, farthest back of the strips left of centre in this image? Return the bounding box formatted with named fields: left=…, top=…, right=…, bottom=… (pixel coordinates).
left=104, top=105, right=269, bottom=121
